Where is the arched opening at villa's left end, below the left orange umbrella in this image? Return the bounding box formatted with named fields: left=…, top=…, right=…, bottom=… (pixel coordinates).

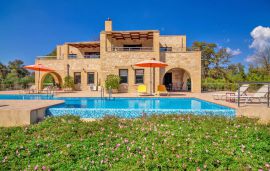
left=40, top=72, right=63, bottom=89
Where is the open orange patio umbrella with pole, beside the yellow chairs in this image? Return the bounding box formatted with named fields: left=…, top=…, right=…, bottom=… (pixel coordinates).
left=135, top=59, right=168, bottom=95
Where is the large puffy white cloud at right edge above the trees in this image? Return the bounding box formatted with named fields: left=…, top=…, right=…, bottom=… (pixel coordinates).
left=246, top=26, right=270, bottom=62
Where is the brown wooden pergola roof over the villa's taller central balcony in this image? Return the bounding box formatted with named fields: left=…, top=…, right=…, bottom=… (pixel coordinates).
left=106, top=31, right=154, bottom=40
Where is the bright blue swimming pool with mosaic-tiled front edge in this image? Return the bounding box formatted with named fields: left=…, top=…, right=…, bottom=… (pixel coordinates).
left=0, top=95, right=235, bottom=118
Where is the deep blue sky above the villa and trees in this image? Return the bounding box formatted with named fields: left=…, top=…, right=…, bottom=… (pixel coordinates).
left=0, top=0, right=270, bottom=65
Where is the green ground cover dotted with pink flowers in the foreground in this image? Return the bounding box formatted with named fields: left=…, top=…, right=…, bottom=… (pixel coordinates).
left=0, top=115, right=270, bottom=170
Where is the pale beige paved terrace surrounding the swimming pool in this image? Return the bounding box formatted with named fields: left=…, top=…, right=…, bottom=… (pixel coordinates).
left=0, top=91, right=270, bottom=123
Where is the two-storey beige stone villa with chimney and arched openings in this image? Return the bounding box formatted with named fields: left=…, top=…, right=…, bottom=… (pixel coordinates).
left=36, top=19, right=201, bottom=92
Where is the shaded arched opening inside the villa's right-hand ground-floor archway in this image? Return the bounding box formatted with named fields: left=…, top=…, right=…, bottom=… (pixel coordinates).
left=163, top=68, right=191, bottom=91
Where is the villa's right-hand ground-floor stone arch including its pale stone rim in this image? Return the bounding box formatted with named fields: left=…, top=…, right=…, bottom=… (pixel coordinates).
left=161, top=67, right=194, bottom=91
